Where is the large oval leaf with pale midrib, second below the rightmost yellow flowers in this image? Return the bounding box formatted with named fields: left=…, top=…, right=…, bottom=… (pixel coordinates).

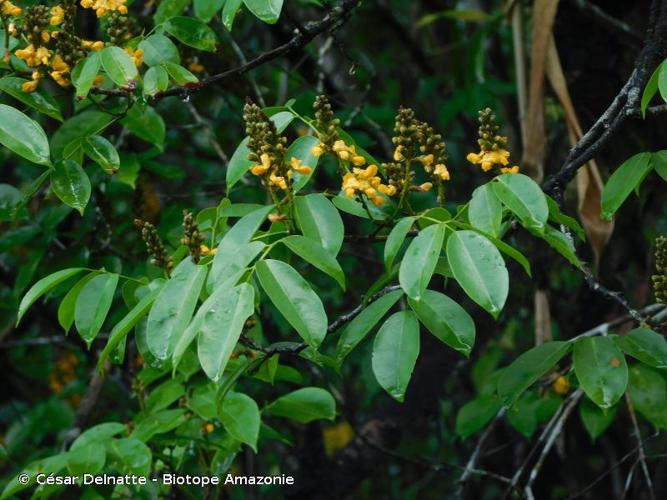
left=447, top=229, right=516, bottom=318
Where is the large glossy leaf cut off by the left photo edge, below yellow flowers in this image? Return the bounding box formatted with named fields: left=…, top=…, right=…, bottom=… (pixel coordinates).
left=0, top=104, right=51, bottom=165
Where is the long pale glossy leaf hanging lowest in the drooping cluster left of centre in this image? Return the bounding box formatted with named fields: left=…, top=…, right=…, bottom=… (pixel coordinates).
left=197, top=283, right=255, bottom=382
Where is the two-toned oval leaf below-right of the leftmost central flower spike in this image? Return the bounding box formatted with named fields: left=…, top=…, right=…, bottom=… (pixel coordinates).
left=294, top=193, right=345, bottom=256
